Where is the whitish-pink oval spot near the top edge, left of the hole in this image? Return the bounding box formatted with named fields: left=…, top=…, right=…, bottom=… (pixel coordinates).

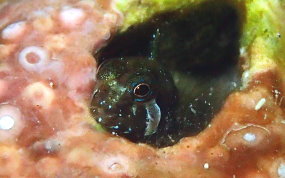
left=59, top=7, right=85, bottom=27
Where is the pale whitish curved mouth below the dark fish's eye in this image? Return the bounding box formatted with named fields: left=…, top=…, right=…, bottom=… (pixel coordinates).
left=144, top=99, right=161, bottom=136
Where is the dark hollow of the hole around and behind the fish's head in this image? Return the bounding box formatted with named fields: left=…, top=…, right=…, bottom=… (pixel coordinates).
left=93, top=2, right=241, bottom=147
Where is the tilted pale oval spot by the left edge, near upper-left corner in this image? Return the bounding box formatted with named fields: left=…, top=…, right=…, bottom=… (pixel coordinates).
left=2, top=21, right=26, bottom=39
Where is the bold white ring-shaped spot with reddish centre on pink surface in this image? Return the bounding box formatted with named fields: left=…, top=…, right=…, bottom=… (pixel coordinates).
left=19, top=46, right=49, bottom=71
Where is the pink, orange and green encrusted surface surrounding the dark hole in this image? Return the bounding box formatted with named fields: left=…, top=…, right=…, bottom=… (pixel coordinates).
left=0, top=0, right=285, bottom=178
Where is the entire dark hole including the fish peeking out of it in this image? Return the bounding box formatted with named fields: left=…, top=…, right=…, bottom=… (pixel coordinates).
left=90, top=3, right=240, bottom=147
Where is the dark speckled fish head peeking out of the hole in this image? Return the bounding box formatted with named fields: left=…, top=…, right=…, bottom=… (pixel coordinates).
left=90, top=57, right=176, bottom=143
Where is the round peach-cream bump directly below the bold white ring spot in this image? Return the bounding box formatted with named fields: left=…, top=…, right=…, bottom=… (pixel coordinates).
left=23, top=82, right=55, bottom=108
